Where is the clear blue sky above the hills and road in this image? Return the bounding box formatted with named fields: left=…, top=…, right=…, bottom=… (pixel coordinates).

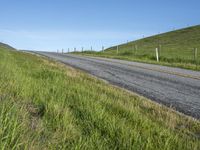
left=0, top=0, right=200, bottom=51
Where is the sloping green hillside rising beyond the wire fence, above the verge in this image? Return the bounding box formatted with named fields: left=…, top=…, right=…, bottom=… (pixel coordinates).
left=108, top=25, right=200, bottom=51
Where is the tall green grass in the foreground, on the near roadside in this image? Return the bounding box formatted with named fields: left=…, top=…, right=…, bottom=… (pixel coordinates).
left=0, top=46, right=200, bottom=150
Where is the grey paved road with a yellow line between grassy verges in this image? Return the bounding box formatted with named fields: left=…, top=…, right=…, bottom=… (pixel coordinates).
left=35, top=52, right=200, bottom=119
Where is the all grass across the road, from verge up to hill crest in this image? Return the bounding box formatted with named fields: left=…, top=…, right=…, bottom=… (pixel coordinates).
left=78, top=25, right=200, bottom=70
